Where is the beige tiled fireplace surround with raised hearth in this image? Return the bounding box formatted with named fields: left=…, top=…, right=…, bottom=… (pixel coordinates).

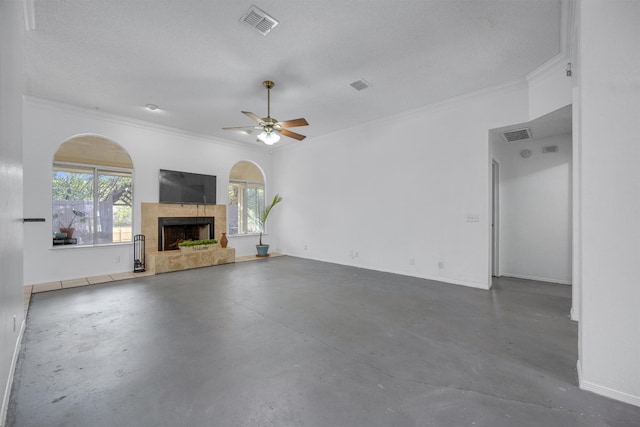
left=142, top=203, right=236, bottom=274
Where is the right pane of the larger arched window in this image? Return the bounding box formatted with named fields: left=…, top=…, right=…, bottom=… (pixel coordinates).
left=96, top=170, right=133, bottom=243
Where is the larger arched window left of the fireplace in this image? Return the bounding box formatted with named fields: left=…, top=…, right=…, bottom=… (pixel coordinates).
left=52, top=135, right=133, bottom=245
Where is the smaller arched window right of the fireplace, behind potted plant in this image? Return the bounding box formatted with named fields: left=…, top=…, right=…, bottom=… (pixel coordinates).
left=227, top=160, right=264, bottom=235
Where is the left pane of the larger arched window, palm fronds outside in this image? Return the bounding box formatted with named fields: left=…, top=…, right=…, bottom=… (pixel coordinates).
left=52, top=167, right=93, bottom=245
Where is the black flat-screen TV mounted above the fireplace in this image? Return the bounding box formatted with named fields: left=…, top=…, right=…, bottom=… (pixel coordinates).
left=159, top=169, right=216, bottom=205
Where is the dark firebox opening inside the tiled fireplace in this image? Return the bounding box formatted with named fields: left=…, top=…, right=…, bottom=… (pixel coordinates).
left=158, top=217, right=215, bottom=251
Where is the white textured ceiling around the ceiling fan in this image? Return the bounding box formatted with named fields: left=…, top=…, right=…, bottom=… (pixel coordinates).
left=24, top=0, right=562, bottom=149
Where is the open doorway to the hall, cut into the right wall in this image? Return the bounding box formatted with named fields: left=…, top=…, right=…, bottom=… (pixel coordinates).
left=489, top=105, right=573, bottom=284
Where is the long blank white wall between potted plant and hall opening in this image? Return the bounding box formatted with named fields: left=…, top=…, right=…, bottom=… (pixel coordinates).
left=274, top=84, right=528, bottom=288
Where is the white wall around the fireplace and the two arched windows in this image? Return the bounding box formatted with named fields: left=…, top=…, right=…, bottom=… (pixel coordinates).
left=24, top=98, right=277, bottom=284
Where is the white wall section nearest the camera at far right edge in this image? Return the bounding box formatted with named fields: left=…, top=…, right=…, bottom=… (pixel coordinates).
left=578, top=0, right=640, bottom=406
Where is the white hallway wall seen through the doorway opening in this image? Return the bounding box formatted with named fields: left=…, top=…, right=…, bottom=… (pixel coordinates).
left=494, top=134, right=572, bottom=284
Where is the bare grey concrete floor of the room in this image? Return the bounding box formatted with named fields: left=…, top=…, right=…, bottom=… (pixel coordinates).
left=7, top=257, right=640, bottom=427
